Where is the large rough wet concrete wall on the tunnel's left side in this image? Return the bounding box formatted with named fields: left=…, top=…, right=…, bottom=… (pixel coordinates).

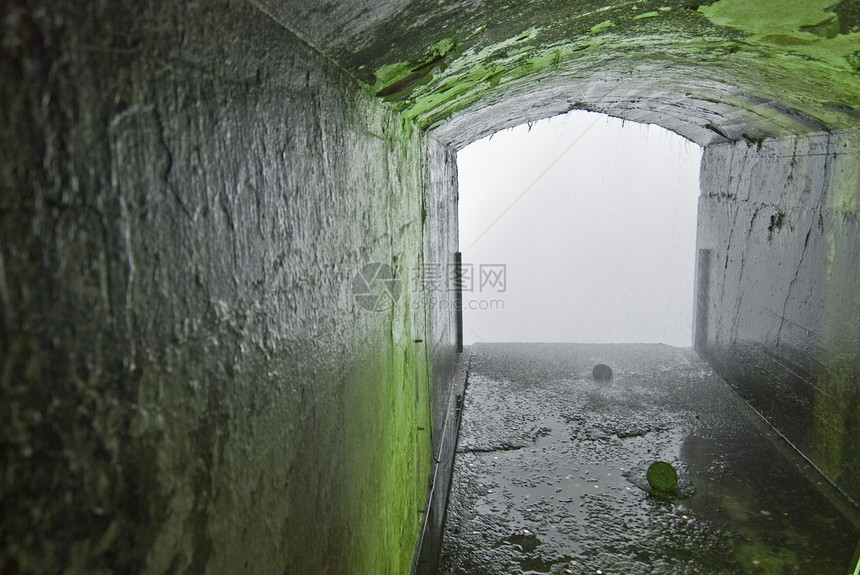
left=0, top=0, right=456, bottom=574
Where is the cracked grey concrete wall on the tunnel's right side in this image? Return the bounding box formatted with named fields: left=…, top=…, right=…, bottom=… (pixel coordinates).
left=696, top=132, right=860, bottom=501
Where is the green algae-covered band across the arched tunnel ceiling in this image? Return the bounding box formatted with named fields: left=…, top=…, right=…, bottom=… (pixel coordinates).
left=358, top=0, right=860, bottom=139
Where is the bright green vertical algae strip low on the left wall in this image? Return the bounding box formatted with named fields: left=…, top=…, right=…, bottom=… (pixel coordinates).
left=338, top=326, right=432, bottom=574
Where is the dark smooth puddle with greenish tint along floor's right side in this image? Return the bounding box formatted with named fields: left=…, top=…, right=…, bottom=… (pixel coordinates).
left=682, top=436, right=858, bottom=575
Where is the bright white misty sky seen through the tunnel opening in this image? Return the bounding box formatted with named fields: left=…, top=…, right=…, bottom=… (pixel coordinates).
left=457, top=111, right=702, bottom=347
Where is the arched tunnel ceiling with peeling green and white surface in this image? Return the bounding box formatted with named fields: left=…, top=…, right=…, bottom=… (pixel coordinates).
left=253, top=0, right=860, bottom=148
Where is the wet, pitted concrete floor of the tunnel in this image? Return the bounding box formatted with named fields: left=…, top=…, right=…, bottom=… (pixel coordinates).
left=441, top=344, right=860, bottom=575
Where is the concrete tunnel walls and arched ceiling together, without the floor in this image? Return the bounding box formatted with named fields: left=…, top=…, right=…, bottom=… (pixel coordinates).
left=0, top=0, right=860, bottom=574
